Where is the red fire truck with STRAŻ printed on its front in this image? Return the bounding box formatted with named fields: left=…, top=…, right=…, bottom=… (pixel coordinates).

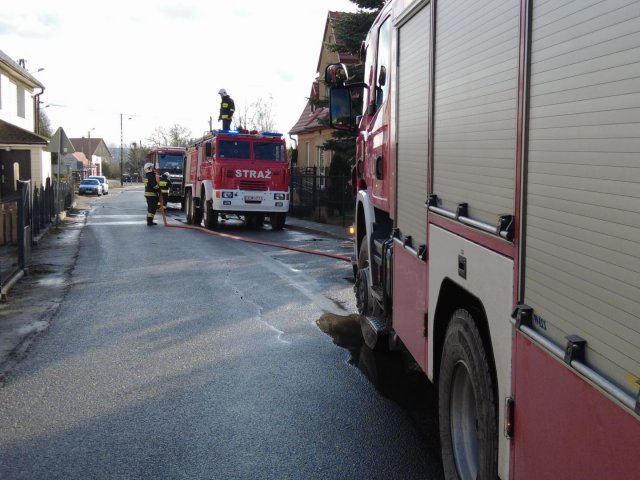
left=184, top=130, right=291, bottom=230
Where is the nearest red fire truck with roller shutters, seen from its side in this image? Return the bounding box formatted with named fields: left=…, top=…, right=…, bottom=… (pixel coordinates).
left=325, top=0, right=640, bottom=480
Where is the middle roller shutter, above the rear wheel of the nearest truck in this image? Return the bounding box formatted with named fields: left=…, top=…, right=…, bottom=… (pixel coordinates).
left=433, top=0, right=520, bottom=225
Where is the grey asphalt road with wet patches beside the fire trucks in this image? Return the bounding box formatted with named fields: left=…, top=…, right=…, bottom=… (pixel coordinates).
left=0, top=190, right=440, bottom=479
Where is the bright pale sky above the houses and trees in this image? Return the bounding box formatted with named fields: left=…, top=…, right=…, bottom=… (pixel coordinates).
left=0, top=0, right=356, bottom=149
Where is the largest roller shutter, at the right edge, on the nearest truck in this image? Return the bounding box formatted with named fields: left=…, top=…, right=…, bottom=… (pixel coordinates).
left=524, top=0, right=640, bottom=398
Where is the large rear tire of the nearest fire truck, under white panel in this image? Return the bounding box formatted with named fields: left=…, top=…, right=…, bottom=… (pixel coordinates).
left=438, top=309, right=498, bottom=480
